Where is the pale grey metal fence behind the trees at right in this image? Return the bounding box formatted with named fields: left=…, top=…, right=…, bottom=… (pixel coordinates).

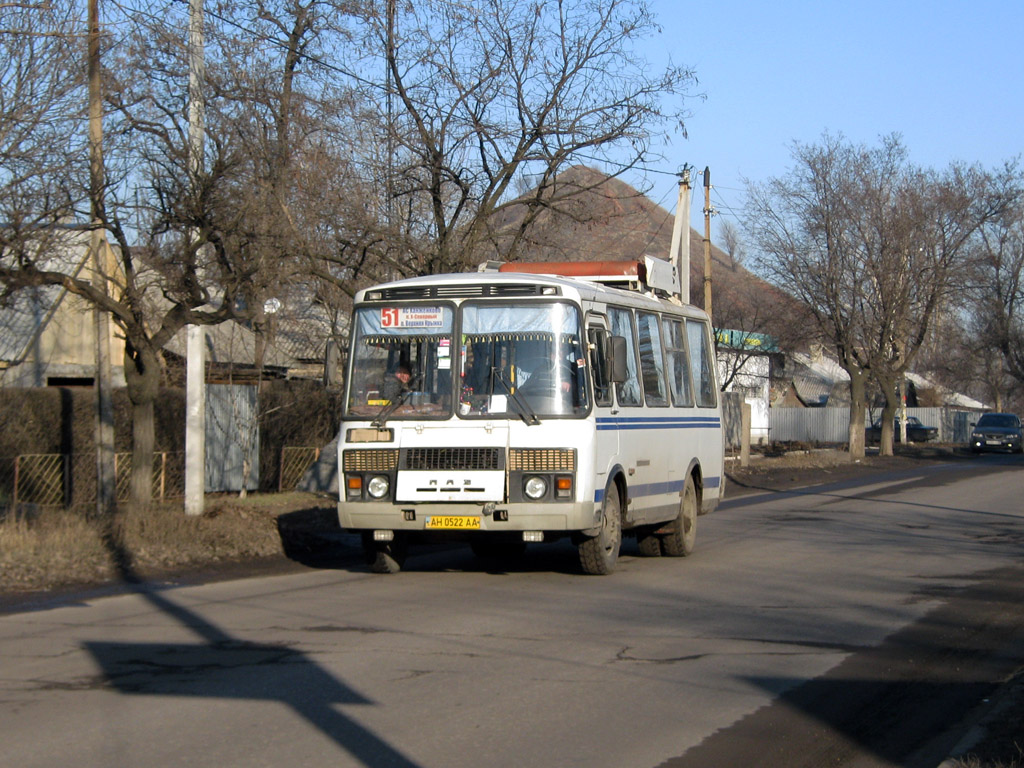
left=768, top=408, right=979, bottom=444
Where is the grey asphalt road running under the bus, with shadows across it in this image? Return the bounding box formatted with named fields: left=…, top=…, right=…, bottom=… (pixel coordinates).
left=0, top=457, right=1024, bottom=768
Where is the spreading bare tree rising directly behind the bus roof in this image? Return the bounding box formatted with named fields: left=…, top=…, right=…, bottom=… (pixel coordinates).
left=331, top=0, right=693, bottom=274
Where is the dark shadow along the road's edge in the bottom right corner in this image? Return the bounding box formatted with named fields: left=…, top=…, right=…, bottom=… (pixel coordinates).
left=662, top=566, right=1024, bottom=768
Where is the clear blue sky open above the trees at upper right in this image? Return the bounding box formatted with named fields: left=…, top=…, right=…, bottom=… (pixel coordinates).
left=626, top=0, right=1024, bottom=231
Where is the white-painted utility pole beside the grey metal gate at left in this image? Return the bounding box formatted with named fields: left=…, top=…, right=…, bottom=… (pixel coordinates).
left=185, top=0, right=206, bottom=515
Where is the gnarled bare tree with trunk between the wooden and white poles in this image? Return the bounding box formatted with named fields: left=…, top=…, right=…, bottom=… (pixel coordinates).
left=0, top=2, right=354, bottom=512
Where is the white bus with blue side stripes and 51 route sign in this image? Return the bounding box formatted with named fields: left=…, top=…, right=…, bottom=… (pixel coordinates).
left=338, top=257, right=724, bottom=573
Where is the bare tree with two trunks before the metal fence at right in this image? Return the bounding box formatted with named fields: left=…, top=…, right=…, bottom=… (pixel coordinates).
left=751, top=134, right=1008, bottom=456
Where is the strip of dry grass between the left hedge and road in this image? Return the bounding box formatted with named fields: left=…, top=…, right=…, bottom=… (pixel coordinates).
left=0, top=494, right=323, bottom=592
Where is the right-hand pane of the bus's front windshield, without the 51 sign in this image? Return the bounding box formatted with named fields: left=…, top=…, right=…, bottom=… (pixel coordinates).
left=459, top=303, right=590, bottom=418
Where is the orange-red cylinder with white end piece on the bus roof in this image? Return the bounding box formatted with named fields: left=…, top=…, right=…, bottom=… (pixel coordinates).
left=487, top=255, right=679, bottom=295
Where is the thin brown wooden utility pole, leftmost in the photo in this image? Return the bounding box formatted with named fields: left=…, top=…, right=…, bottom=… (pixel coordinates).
left=87, top=0, right=117, bottom=515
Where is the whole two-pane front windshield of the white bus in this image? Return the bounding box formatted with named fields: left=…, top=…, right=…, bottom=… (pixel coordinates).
left=346, top=302, right=590, bottom=423
